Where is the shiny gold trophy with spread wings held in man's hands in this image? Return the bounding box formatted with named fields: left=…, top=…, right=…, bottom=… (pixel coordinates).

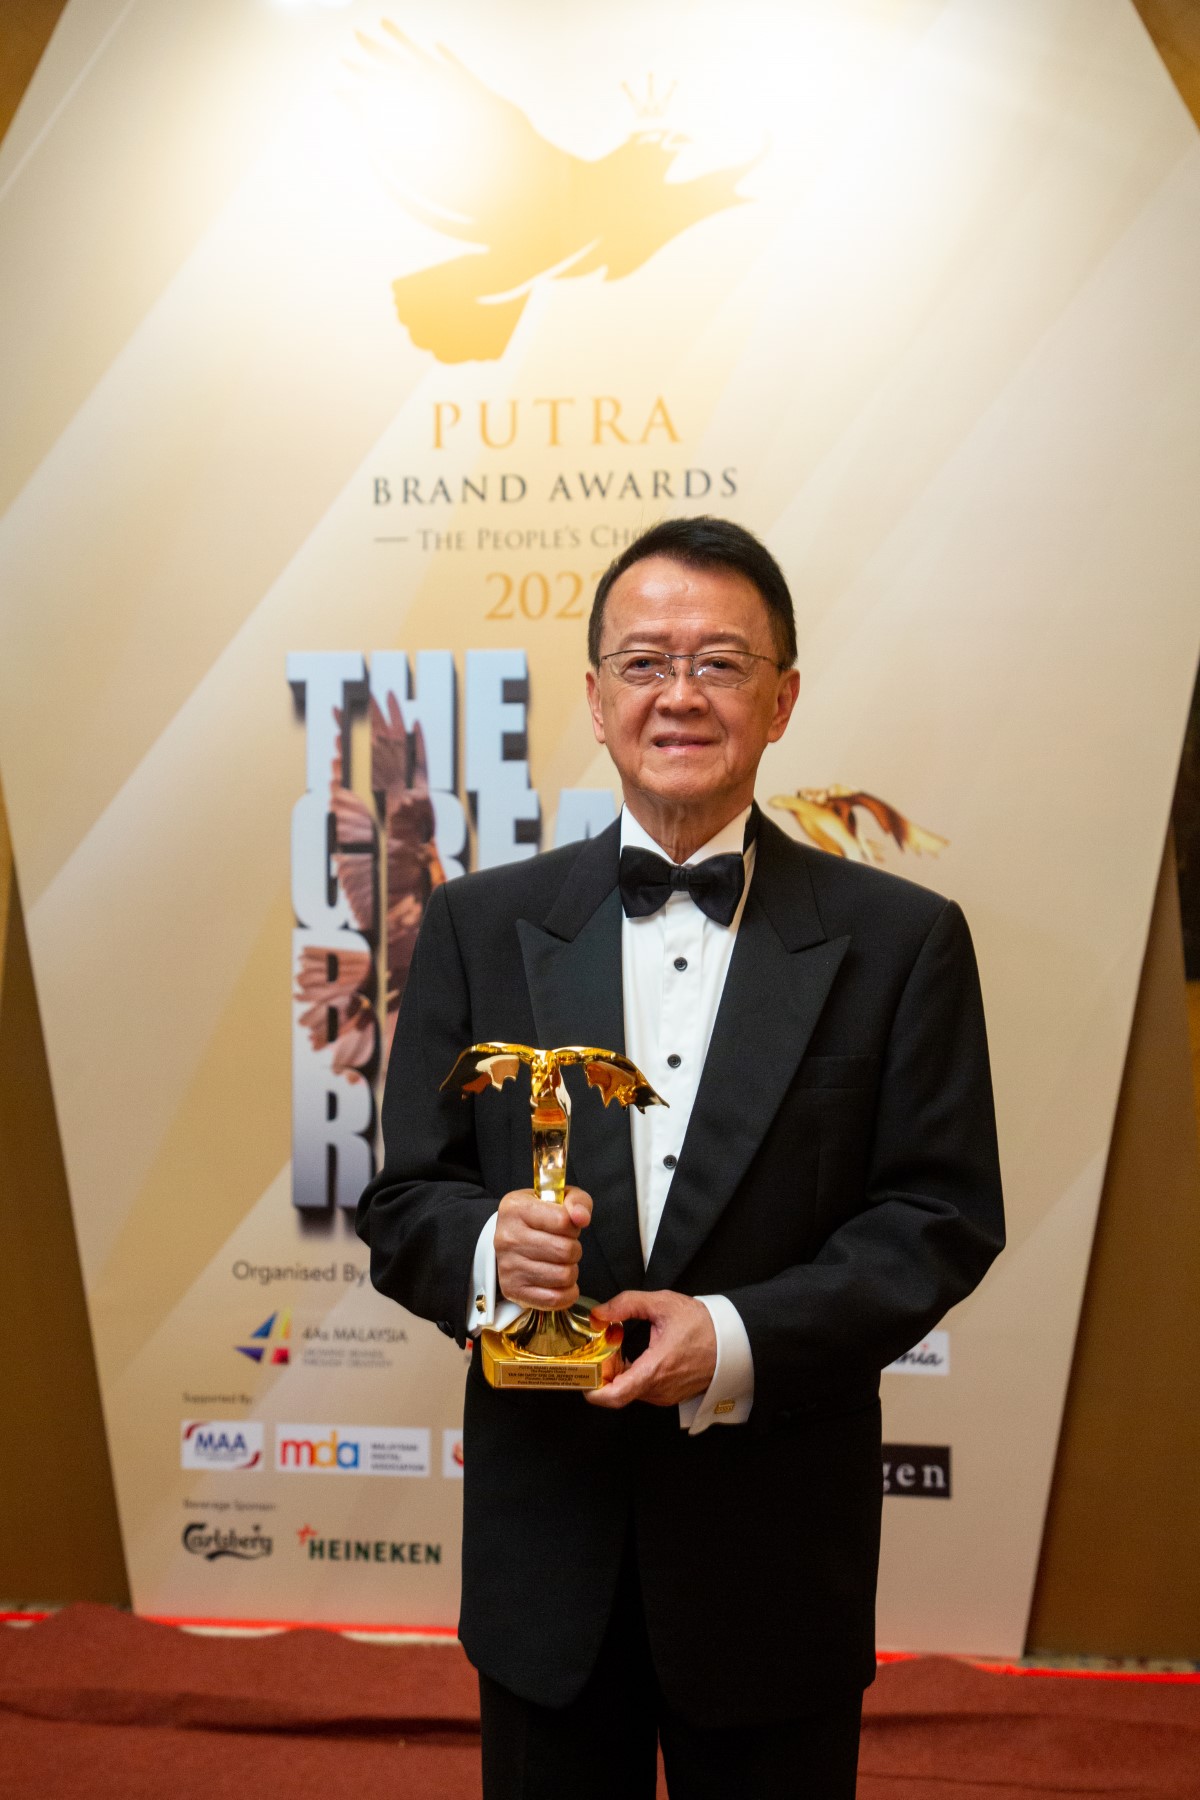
left=443, top=1044, right=666, bottom=1388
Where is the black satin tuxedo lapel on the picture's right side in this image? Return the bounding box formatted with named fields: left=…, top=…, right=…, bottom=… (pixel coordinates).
left=644, top=821, right=849, bottom=1289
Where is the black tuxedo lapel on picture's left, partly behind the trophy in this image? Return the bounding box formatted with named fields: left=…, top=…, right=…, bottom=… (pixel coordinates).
left=516, top=821, right=646, bottom=1289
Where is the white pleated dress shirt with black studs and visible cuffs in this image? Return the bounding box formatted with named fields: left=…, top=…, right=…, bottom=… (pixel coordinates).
left=466, top=806, right=754, bottom=1435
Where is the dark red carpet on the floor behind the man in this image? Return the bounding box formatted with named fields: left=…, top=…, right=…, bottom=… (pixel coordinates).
left=0, top=1606, right=1200, bottom=1800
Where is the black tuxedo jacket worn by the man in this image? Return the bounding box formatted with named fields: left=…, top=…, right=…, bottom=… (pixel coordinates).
left=358, top=821, right=1004, bottom=1724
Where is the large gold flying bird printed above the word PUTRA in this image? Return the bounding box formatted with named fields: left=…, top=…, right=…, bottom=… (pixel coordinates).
left=347, top=20, right=765, bottom=364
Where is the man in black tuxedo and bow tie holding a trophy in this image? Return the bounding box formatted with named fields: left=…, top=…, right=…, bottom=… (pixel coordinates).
left=358, top=518, right=1004, bottom=1800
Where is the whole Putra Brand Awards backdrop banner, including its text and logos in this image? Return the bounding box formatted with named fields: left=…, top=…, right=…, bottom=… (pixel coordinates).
left=0, top=0, right=1200, bottom=1656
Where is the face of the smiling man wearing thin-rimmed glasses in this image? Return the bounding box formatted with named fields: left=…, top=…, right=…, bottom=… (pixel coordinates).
left=587, top=556, right=801, bottom=812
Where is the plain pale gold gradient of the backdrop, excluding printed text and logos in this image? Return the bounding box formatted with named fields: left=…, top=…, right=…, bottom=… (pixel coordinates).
left=0, top=0, right=1200, bottom=1652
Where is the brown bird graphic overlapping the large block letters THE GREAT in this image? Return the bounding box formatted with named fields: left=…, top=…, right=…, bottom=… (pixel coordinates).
left=295, top=695, right=446, bottom=1080
